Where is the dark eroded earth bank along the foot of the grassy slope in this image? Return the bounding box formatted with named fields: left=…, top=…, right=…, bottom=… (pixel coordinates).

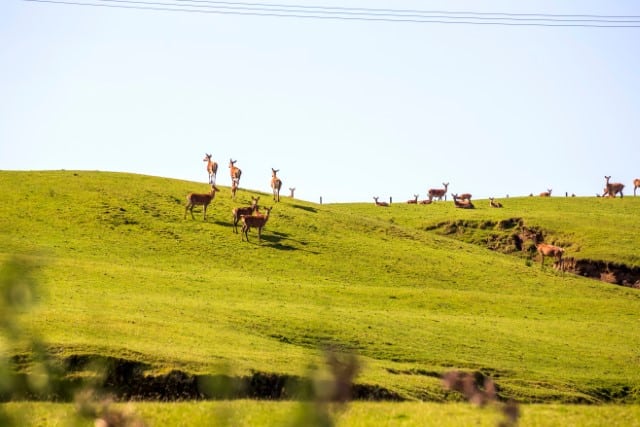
left=0, top=355, right=404, bottom=402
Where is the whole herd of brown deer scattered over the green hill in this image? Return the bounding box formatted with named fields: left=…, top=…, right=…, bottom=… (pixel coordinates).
left=184, top=157, right=640, bottom=260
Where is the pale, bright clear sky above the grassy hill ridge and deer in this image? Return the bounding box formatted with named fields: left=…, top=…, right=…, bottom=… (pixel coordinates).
left=0, top=0, right=640, bottom=203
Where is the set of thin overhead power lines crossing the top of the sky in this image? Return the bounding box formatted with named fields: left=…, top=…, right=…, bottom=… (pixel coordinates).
left=23, top=0, right=640, bottom=28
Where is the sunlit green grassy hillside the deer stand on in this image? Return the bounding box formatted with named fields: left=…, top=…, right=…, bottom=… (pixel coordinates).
left=0, top=171, right=640, bottom=401
